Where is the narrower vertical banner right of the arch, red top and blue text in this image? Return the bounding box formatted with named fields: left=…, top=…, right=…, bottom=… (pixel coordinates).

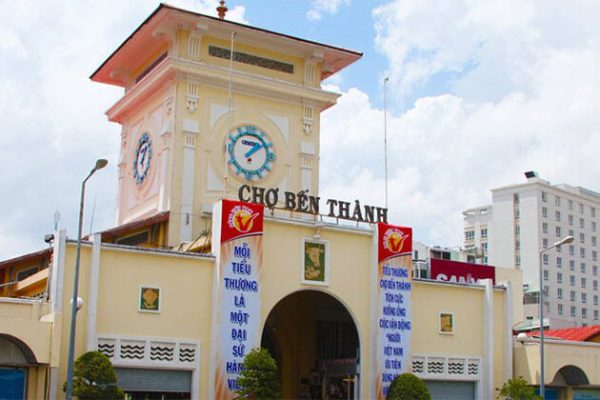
left=375, top=223, right=412, bottom=399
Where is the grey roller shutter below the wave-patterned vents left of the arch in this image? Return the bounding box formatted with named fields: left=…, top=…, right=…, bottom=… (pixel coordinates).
left=115, top=368, right=192, bottom=393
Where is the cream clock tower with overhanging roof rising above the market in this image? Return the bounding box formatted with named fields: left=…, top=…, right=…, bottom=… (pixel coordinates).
left=91, top=4, right=361, bottom=246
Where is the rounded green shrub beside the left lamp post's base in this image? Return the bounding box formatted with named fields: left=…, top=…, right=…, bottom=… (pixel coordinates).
left=63, top=351, right=125, bottom=400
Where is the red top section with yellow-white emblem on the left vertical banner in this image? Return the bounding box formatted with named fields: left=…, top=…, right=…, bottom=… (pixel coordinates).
left=221, top=200, right=265, bottom=243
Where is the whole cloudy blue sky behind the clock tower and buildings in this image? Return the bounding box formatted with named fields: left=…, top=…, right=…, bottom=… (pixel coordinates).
left=0, top=0, right=600, bottom=260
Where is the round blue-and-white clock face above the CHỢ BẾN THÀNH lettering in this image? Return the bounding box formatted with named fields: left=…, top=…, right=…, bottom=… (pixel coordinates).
left=227, top=125, right=275, bottom=181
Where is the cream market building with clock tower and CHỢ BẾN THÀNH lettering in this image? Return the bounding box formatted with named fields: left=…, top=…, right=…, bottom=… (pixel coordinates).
left=0, top=5, right=592, bottom=399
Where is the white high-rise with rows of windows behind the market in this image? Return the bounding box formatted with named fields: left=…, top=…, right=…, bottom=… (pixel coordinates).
left=463, top=173, right=600, bottom=327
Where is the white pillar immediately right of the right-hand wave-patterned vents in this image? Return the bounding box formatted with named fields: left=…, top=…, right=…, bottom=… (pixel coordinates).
left=481, top=279, right=495, bottom=399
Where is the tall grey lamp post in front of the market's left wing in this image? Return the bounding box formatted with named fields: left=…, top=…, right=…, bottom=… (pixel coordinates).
left=67, top=158, right=108, bottom=400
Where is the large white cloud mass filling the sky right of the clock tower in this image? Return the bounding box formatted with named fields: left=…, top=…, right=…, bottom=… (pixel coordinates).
left=321, top=1, right=600, bottom=245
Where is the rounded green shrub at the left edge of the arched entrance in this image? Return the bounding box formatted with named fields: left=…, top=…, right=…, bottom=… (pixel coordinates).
left=237, top=349, right=280, bottom=400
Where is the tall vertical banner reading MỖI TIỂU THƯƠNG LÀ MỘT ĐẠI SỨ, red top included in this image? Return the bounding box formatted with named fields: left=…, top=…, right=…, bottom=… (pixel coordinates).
left=211, top=200, right=264, bottom=399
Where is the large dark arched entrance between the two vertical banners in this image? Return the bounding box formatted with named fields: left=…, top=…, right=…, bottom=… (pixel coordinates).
left=261, top=290, right=360, bottom=399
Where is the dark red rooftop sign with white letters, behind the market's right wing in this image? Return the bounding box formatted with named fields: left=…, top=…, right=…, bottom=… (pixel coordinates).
left=431, top=258, right=496, bottom=284
